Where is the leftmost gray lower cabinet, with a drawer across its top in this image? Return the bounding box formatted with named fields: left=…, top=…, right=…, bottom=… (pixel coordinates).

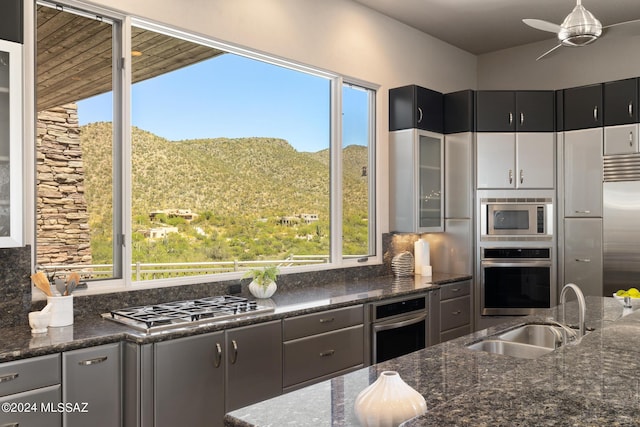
left=0, top=354, right=62, bottom=427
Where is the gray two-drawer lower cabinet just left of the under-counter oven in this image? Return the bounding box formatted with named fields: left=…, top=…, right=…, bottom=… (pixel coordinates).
left=282, top=305, right=365, bottom=391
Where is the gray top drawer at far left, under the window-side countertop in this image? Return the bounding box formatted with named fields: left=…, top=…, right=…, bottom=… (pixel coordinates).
left=0, top=354, right=60, bottom=396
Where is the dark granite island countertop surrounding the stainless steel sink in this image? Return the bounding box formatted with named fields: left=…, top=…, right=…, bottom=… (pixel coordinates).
left=225, top=297, right=640, bottom=427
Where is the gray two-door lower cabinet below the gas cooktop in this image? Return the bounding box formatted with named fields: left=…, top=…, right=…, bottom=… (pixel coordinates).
left=153, top=321, right=282, bottom=427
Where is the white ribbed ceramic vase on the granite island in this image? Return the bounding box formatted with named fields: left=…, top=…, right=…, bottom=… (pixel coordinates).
left=355, top=371, right=427, bottom=427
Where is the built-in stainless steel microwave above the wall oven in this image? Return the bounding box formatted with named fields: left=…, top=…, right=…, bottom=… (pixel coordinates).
left=480, top=198, right=553, bottom=240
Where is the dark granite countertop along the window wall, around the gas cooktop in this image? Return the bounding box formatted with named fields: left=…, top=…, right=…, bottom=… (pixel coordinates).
left=0, top=273, right=471, bottom=362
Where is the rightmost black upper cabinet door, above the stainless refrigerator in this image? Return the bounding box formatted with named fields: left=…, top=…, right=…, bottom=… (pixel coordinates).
left=603, top=78, right=638, bottom=126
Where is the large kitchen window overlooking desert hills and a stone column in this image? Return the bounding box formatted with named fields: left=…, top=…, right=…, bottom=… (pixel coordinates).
left=36, top=2, right=376, bottom=290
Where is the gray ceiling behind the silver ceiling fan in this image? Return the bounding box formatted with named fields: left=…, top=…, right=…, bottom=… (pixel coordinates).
left=354, top=0, right=640, bottom=55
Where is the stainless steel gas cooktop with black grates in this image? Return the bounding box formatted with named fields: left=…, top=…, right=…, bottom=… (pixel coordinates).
left=102, top=295, right=274, bottom=333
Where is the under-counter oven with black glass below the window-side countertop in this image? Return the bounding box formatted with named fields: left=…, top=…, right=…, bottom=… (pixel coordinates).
left=370, top=295, right=429, bottom=363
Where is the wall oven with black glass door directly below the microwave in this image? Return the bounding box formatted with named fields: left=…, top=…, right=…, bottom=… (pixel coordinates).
left=480, top=247, right=556, bottom=315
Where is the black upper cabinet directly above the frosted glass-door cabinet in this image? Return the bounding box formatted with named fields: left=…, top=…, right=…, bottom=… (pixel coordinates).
left=389, top=85, right=444, bottom=133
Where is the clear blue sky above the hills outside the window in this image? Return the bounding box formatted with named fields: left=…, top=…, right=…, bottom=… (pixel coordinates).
left=78, top=54, right=368, bottom=152
